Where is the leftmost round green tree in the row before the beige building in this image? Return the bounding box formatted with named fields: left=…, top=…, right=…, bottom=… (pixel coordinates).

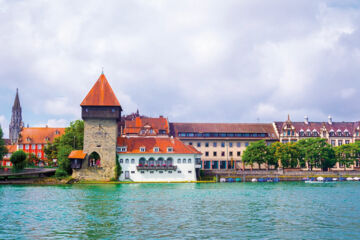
left=242, top=140, right=268, bottom=169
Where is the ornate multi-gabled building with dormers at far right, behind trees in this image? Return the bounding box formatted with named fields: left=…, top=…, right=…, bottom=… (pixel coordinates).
left=274, top=115, right=360, bottom=170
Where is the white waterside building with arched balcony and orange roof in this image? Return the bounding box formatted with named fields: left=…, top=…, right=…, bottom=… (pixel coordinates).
left=117, top=137, right=201, bottom=182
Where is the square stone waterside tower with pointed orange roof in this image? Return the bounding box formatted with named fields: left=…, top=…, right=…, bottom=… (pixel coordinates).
left=73, top=73, right=122, bottom=180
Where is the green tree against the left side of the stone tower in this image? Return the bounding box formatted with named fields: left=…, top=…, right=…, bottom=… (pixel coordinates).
left=44, top=120, right=84, bottom=174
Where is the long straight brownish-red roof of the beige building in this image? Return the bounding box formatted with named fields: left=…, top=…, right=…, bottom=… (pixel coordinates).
left=170, top=123, right=276, bottom=138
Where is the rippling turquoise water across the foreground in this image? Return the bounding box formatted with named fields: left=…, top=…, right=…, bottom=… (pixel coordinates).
left=0, top=182, right=360, bottom=239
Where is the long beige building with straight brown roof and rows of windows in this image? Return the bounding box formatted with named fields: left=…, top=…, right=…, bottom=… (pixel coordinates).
left=170, top=123, right=278, bottom=170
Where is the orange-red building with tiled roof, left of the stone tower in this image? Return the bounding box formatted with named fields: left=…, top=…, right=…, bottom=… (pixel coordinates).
left=17, top=127, right=65, bottom=161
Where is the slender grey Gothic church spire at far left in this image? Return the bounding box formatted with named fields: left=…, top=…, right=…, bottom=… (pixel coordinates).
left=9, top=89, right=23, bottom=144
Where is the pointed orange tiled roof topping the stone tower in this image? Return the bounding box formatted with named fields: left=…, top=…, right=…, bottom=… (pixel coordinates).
left=80, top=73, right=121, bottom=107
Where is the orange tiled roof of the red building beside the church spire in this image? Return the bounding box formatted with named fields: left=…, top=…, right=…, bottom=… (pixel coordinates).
left=18, top=127, right=65, bottom=144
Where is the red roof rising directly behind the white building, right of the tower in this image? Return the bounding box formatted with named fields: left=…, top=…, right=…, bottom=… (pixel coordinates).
left=124, top=117, right=169, bottom=134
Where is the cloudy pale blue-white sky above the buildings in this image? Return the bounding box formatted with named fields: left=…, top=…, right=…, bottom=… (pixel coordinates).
left=0, top=0, right=360, bottom=136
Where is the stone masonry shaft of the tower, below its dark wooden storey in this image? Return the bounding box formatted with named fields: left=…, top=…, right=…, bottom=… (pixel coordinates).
left=73, top=119, right=118, bottom=180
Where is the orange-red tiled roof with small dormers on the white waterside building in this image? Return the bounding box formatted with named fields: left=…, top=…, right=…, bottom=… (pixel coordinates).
left=117, top=137, right=201, bottom=154
